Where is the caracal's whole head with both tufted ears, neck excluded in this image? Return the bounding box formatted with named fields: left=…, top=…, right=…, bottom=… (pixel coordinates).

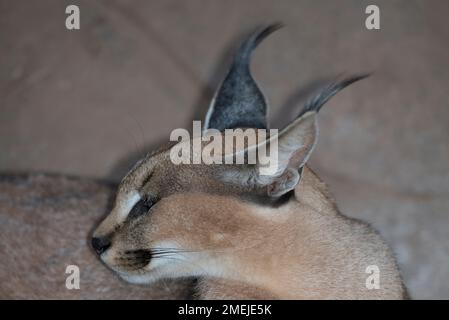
left=92, top=26, right=361, bottom=283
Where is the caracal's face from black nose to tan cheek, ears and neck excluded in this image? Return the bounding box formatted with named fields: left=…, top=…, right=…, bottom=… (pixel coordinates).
left=94, top=139, right=266, bottom=283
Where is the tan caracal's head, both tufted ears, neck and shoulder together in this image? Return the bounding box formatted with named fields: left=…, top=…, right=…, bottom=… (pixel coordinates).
left=92, top=25, right=406, bottom=299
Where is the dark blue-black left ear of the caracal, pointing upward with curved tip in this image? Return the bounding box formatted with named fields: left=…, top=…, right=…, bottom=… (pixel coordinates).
left=204, top=24, right=282, bottom=131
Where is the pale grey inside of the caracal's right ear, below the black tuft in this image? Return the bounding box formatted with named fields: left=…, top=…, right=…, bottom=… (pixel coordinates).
left=267, top=111, right=318, bottom=197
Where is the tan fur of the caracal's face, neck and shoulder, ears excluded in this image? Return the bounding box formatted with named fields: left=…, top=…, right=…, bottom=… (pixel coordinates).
left=95, top=141, right=406, bottom=299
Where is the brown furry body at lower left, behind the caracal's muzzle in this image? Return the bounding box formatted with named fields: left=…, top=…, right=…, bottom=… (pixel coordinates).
left=0, top=174, right=192, bottom=300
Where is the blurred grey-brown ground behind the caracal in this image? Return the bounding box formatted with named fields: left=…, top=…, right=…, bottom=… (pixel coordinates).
left=0, top=0, right=449, bottom=299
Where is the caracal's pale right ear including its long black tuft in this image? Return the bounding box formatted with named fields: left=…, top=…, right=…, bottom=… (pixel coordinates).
left=214, top=67, right=368, bottom=198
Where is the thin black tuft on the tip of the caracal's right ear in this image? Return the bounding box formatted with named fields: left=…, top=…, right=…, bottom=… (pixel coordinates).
left=298, top=74, right=370, bottom=117
